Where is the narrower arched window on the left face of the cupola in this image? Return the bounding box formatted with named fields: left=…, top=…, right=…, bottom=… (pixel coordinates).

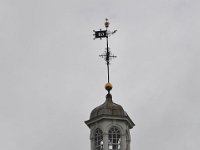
left=95, top=128, right=103, bottom=150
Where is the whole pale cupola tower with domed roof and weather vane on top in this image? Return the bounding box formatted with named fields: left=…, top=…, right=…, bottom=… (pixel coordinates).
left=85, top=19, right=135, bottom=150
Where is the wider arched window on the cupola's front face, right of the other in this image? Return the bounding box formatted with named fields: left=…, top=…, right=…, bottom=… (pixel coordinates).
left=108, top=127, right=121, bottom=150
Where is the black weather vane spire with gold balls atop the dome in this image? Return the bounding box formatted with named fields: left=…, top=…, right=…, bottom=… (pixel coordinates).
left=93, top=18, right=117, bottom=93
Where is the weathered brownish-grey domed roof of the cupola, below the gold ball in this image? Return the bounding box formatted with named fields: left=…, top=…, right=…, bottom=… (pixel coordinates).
left=90, top=94, right=128, bottom=119
